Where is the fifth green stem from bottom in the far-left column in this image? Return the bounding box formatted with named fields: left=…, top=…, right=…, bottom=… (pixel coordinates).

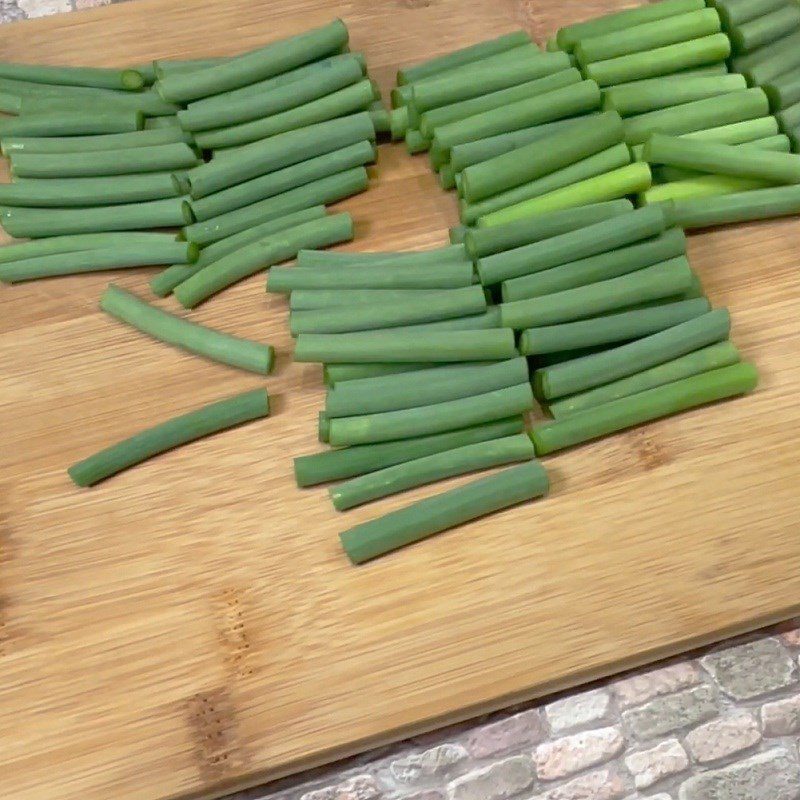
left=10, top=142, right=201, bottom=178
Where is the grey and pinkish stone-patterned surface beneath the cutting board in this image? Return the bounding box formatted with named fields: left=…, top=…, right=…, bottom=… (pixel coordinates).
left=0, top=0, right=800, bottom=800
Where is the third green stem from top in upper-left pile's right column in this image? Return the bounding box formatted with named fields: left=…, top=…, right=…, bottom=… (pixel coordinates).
left=194, top=80, right=377, bottom=150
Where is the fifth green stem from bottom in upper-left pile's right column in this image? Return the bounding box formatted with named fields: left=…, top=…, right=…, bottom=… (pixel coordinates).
left=191, top=140, right=376, bottom=222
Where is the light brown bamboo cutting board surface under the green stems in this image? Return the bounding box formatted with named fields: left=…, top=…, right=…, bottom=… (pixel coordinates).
left=0, top=0, right=800, bottom=800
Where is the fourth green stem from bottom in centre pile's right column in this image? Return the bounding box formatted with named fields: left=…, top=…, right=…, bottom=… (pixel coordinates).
left=520, top=297, right=711, bottom=356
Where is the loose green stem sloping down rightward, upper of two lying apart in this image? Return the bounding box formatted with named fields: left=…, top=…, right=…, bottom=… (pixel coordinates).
left=100, top=284, right=275, bottom=375
